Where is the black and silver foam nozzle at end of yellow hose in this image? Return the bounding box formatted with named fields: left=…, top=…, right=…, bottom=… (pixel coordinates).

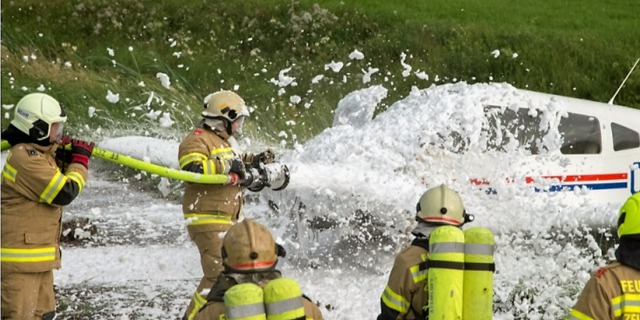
left=245, top=163, right=290, bottom=192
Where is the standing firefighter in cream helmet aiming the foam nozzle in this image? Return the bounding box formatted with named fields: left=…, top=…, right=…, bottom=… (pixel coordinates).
left=178, top=90, right=273, bottom=319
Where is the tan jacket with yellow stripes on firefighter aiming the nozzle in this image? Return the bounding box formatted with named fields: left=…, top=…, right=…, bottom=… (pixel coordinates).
left=178, top=128, right=244, bottom=232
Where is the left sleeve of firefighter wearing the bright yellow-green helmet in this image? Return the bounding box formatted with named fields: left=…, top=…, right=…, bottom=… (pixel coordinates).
left=570, top=275, right=612, bottom=320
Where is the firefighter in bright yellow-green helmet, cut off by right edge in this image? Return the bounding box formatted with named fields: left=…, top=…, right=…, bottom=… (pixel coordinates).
left=569, top=193, right=640, bottom=320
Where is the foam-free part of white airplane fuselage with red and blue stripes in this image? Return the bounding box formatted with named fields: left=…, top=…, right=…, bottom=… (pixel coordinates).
left=471, top=89, right=640, bottom=203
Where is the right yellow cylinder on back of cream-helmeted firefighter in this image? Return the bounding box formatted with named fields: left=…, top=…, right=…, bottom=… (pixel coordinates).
left=462, top=227, right=495, bottom=320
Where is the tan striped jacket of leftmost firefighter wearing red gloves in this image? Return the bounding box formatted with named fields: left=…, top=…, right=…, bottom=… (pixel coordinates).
left=0, top=143, right=87, bottom=272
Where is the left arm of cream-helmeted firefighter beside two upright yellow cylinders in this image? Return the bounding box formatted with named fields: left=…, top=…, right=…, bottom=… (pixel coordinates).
left=377, top=257, right=413, bottom=320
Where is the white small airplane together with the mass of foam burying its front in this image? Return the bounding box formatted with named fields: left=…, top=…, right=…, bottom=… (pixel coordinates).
left=262, top=62, right=640, bottom=256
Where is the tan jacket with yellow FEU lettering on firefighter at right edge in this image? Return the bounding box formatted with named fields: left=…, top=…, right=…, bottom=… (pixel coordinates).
left=569, top=262, right=640, bottom=320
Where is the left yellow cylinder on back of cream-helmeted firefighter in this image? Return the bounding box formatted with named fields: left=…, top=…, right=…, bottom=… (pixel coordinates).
left=427, top=226, right=464, bottom=320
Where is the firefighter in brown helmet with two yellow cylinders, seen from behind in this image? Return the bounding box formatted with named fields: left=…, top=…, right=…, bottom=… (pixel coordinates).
left=194, top=219, right=323, bottom=320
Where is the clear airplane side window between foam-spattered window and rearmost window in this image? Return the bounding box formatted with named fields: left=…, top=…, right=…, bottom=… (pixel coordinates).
left=558, top=112, right=602, bottom=154
